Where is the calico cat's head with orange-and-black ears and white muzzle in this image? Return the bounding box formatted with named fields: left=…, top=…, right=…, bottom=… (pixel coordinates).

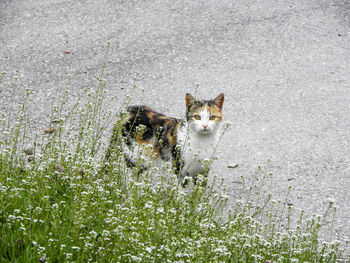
left=186, top=93, right=224, bottom=134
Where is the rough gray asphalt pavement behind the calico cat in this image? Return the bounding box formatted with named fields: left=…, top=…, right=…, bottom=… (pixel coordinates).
left=0, top=0, right=350, bottom=254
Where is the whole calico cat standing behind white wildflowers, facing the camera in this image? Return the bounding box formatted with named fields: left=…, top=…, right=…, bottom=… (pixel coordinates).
left=106, top=93, right=224, bottom=186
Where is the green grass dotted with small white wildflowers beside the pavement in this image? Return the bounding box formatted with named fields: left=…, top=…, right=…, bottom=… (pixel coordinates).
left=0, top=69, right=344, bottom=263
